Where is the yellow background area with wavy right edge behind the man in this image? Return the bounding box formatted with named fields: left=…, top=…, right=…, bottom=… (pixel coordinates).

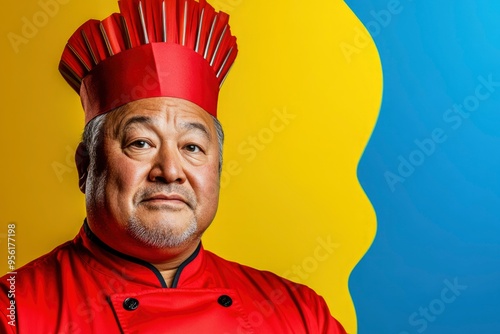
left=0, top=0, right=382, bottom=333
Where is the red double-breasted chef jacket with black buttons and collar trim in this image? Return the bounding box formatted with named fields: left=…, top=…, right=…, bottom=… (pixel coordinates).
left=0, top=224, right=345, bottom=334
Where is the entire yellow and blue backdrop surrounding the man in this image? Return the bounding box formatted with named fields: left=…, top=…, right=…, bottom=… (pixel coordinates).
left=0, top=0, right=500, bottom=334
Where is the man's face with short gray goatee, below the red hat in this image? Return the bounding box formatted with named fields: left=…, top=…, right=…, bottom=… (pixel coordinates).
left=87, top=98, right=219, bottom=261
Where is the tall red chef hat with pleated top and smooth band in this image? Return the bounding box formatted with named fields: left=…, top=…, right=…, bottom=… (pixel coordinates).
left=59, top=0, right=238, bottom=124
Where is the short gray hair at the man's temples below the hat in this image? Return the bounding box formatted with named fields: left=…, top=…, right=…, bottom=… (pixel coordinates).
left=82, top=108, right=224, bottom=178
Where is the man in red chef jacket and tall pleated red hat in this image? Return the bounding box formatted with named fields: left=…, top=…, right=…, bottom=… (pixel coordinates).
left=1, top=0, right=345, bottom=333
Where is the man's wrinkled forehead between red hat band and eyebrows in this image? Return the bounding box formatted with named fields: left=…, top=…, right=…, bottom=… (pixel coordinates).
left=106, top=97, right=215, bottom=136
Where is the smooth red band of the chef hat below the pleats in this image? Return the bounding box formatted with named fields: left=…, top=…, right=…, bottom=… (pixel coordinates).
left=80, top=43, right=219, bottom=124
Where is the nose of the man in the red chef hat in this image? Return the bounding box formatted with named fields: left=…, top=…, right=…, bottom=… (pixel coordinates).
left=149, top=143, right=186, bottom=184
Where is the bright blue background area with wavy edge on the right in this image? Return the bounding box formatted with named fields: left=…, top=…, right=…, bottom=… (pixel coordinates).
left=346, top=0, right=500, bottom=334
